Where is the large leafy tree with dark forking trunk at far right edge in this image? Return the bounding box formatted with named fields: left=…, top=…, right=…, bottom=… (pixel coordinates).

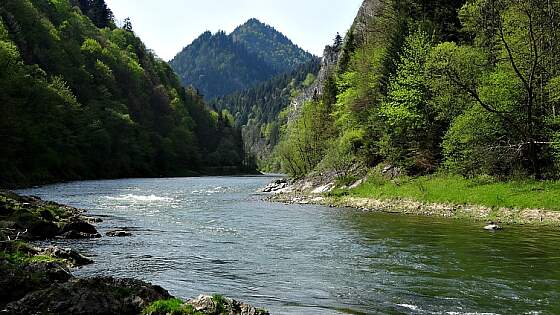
left=430, top=0, right=560, bottom=178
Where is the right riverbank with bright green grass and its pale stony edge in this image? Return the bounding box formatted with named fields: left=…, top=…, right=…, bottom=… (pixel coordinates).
left=268, top=174, right=560, bottom=226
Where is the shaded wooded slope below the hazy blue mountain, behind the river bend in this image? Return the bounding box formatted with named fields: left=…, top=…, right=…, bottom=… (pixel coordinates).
left=209, top=58, right=319, bottom=170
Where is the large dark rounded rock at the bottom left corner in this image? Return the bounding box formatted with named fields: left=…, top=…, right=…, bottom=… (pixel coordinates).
left=6, top=278, right=171, bottom=315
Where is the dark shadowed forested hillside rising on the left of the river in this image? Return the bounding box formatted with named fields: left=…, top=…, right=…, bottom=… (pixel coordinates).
left=0, top=0, right=249, bottom=186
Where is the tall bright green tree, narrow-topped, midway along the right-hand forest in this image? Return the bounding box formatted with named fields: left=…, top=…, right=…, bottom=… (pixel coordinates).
left=380, top=31, right=442, bottom=173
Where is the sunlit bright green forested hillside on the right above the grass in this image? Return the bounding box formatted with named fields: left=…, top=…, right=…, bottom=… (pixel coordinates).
left=277, top=0, right=560, bottom=178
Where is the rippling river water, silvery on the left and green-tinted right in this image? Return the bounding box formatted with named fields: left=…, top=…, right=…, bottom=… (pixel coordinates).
left=20, top=177, right=560, bottom=314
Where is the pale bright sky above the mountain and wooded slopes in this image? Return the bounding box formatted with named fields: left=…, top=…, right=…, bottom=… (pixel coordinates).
left=105, top=0, right=363, bottom=60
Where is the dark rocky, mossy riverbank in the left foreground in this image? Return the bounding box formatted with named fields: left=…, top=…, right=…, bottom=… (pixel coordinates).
left=0, top=191, right=268, bottom=315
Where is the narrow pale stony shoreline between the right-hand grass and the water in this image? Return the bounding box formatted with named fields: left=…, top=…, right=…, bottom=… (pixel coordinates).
left=266, top=185, right=560, bottom=228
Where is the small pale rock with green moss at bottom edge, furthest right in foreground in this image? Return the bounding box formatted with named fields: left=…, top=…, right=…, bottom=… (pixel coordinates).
left=187, top=295, right=269, bottom=315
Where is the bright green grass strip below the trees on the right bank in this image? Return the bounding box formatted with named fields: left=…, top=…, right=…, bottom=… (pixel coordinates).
left=342, top=175, right=560, bottom=210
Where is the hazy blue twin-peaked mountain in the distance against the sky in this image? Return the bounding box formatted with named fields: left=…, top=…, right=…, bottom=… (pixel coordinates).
left=169, top=19, right=315, bottom=100
